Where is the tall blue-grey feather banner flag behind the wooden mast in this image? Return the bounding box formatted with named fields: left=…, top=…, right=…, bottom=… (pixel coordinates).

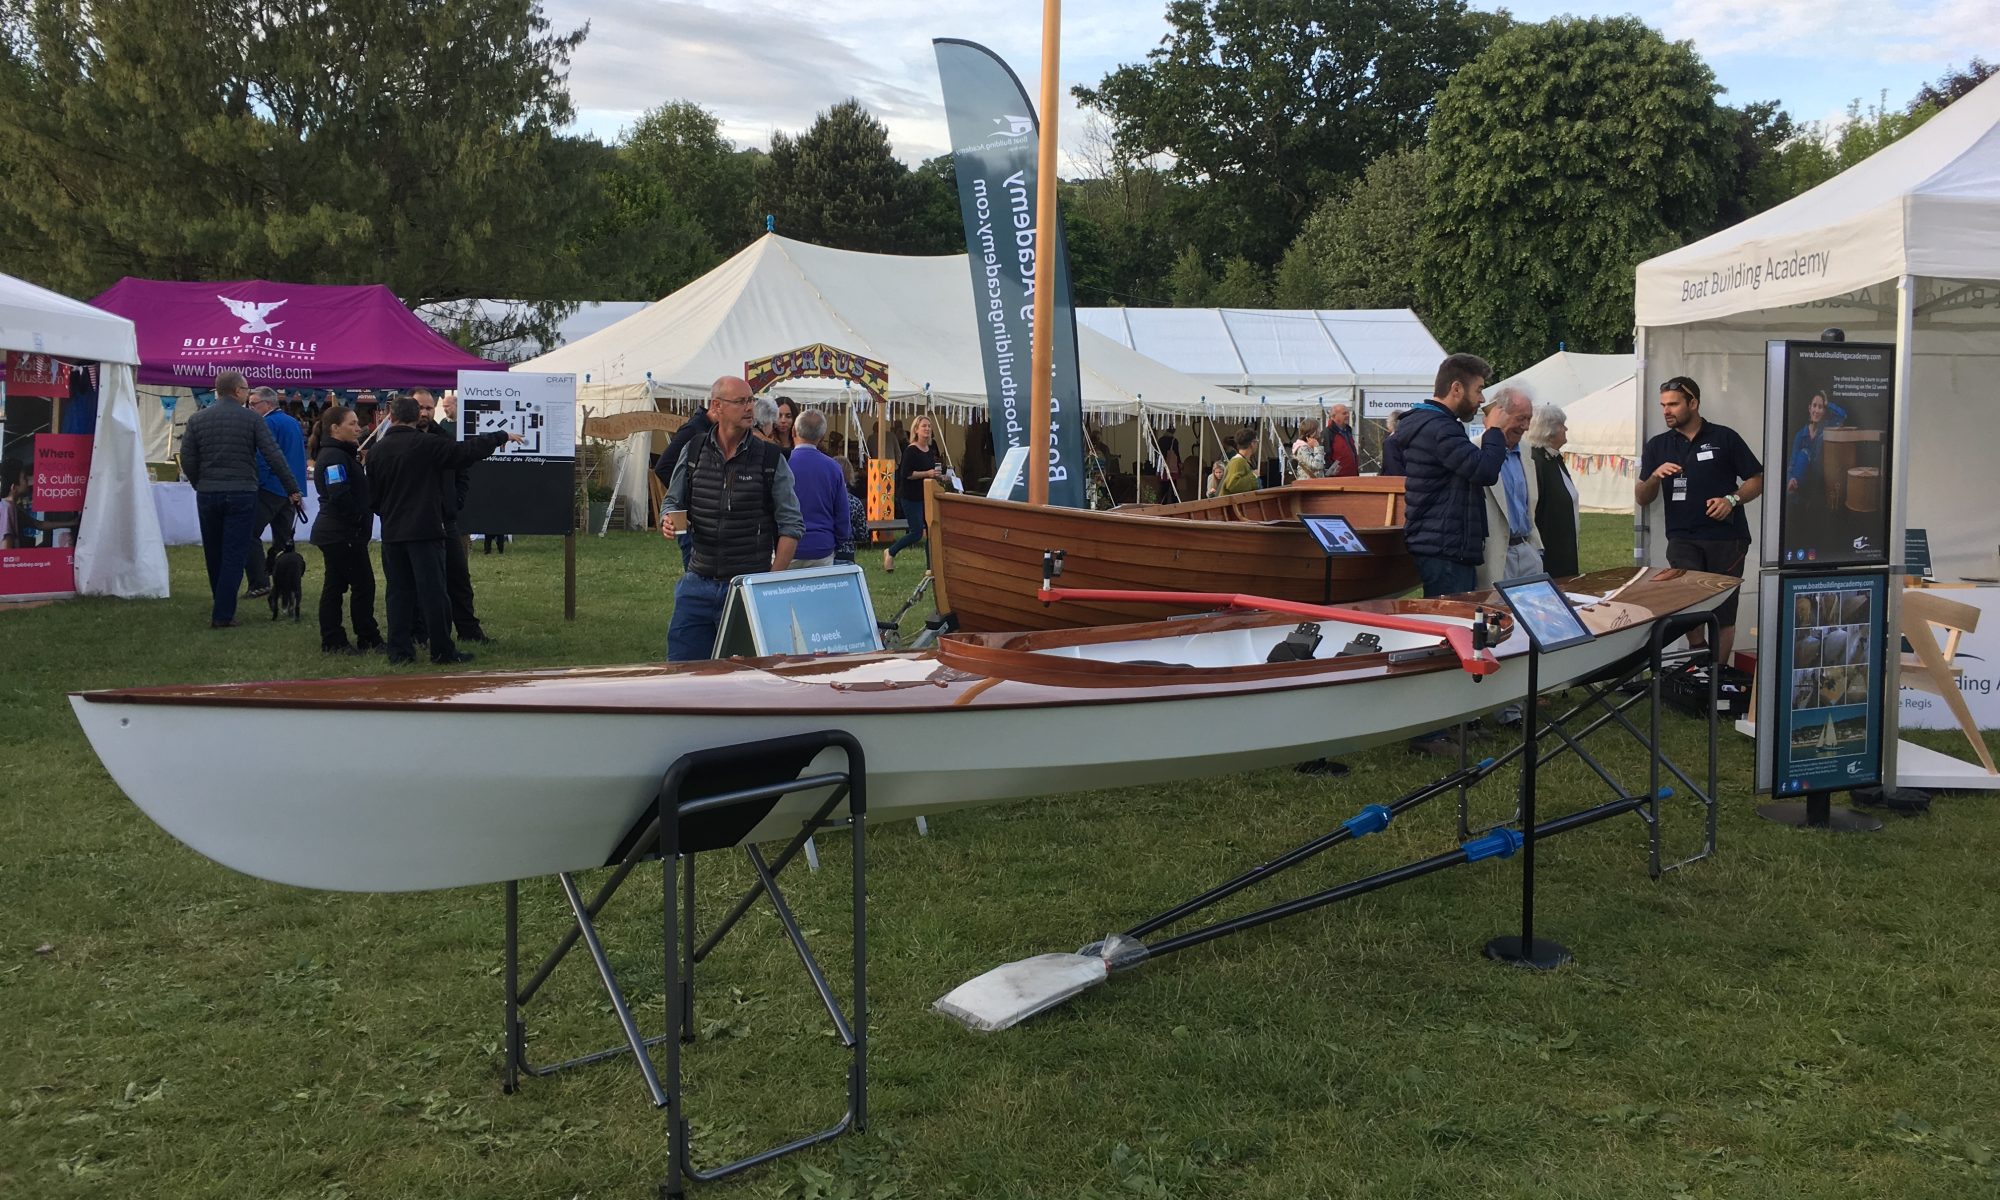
left=932, top=38, right=1084, bottom=508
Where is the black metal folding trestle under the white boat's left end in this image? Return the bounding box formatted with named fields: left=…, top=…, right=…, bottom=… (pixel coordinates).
left=502, top=730, right=868, bottom=1198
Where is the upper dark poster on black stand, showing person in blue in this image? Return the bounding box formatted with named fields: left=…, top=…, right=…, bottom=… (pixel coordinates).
left=1762, top=342, right=1896, bottom=568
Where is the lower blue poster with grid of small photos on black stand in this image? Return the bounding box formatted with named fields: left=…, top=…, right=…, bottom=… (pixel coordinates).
left=1758, top=572, right=1888, bottom=796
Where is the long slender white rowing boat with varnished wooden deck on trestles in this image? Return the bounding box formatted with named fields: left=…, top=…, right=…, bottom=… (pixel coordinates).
left=70, top=570, right=1736, bottom=892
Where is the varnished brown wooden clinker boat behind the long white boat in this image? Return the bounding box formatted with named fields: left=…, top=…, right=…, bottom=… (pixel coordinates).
left=926, top=476, right=1418, bottom=632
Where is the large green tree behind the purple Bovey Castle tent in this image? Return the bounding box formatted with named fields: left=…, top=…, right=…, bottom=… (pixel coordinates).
left=0, top=0, right=602, bottom=338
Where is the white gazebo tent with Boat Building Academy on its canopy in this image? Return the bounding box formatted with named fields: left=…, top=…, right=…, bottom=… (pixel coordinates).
left=1636, top=80, right=2000, bottom=786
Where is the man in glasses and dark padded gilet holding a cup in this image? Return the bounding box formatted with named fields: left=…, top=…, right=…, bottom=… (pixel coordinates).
left=660, top=376, right=806, bottom=662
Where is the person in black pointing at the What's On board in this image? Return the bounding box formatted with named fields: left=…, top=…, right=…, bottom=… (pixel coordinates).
left=368, top=396, right=520, bottom=664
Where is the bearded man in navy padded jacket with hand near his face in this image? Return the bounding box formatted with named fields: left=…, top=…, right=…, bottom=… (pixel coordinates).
left=1396, top=354, right=1520, bottom=596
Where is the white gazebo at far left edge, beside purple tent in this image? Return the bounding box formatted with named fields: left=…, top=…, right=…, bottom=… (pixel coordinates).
left=0, top=274, right=166, bottom=598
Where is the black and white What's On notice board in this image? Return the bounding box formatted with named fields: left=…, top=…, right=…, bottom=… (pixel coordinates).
left=458, top=370, right=576, bottom=534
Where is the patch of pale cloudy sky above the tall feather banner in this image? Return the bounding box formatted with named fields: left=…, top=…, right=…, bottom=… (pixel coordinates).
left=548, top=0, right=1166, bottom=164
